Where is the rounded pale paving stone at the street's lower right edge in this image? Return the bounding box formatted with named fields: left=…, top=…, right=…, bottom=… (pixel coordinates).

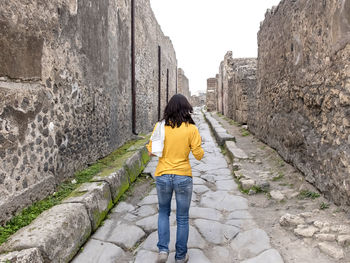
left=231, top=228, right=271, bottom=260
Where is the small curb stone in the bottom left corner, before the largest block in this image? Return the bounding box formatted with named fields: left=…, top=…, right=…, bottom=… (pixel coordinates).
left=0, top=248, right=44, bottom=263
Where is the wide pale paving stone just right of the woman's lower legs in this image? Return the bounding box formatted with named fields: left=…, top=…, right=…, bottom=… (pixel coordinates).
left=194, top=219, right=239, bottom=245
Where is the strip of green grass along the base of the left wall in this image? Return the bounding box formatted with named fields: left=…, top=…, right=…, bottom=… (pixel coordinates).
left=0, top=136, right=149, bottom=248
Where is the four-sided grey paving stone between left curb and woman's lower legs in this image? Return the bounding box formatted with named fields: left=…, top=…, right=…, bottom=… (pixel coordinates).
left=93, top=222, right=145, bottom=249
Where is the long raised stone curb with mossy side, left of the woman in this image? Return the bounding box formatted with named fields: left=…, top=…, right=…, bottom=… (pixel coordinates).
left=0, top=146, right=149, bottom=263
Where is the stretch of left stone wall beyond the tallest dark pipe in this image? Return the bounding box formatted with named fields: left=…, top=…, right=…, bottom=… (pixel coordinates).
left=135, top=0, right=177, bottom=128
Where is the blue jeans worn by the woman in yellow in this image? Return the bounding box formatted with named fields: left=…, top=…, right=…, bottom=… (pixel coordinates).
left=156, top=174, right=193, bottom=260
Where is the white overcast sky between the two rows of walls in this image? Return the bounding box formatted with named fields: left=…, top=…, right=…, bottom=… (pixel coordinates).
left=150, top=0, right=280, bottom=94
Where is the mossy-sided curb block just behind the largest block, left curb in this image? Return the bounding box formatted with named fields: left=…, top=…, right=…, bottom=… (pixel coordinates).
left=63, top=182, right=113, bottom=231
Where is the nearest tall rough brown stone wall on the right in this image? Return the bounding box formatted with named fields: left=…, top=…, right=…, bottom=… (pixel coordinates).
left=254, top=0, right=350, bottom=205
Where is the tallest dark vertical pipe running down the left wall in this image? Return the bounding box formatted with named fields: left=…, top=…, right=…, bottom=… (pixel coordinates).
left=131, top=0, right=137, bottom=135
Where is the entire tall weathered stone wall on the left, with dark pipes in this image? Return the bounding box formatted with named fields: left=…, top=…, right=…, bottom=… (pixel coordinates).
left=0, top=0, right=177, bottom=227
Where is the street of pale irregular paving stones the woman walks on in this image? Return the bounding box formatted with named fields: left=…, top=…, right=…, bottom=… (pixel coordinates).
left=73, top=108, right=283, bottom=263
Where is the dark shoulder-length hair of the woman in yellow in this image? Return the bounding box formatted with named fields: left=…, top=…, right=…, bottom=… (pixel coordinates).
left=163, top=94, right=195, bottom=128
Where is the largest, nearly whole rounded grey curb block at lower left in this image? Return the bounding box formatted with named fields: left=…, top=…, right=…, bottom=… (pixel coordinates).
left=0, top=203, right=91, bottom=263
